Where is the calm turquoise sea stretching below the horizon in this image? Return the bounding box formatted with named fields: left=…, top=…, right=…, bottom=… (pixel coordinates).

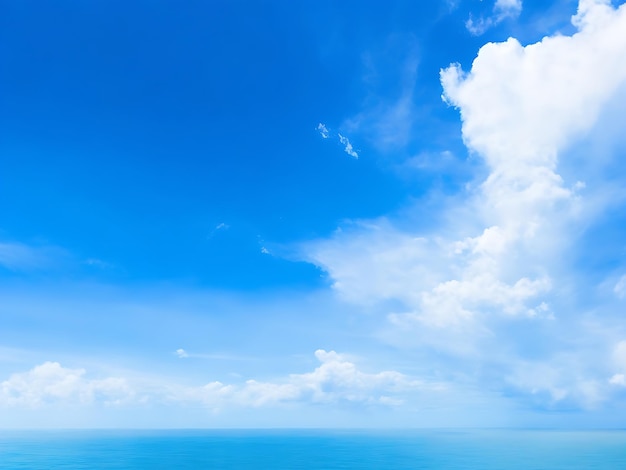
left=0, top=430, right=626, bottom=470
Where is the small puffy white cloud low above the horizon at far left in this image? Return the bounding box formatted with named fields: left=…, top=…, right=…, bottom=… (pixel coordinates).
left=0, top=362, right=134, bottom=408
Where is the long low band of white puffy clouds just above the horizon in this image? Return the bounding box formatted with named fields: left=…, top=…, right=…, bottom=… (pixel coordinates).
left=0, top=349, right=428, bottom=409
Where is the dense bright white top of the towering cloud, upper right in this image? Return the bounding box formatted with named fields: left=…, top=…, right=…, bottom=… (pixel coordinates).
left=441, top=2, right=626, bottom=169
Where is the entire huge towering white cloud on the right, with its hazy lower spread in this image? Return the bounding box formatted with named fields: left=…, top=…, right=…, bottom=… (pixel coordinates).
left=303, top=0, right=626, bottom=406
